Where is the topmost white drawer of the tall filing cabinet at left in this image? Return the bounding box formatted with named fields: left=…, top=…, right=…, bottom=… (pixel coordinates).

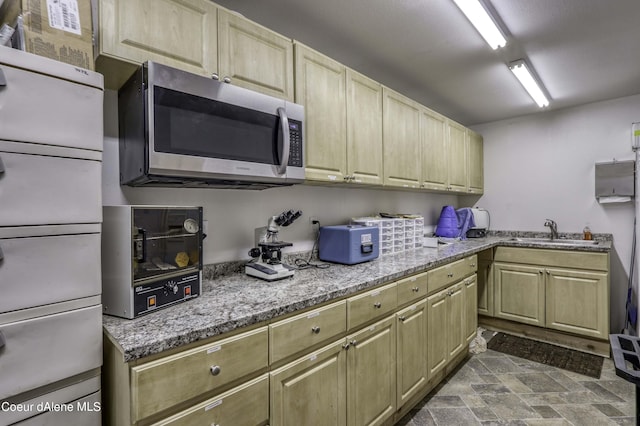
left=0, top=64, right=104, bottom=151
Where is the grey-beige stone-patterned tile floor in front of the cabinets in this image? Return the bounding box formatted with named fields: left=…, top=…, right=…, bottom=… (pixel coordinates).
left=397, top=332, right=635, bottom=426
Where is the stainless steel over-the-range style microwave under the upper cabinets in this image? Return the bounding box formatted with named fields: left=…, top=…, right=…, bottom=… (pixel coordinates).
left=118, top=62, right=305, bottom=189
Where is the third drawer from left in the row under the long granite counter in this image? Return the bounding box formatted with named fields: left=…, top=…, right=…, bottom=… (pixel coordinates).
left=347, top=283, right=398, bottom=330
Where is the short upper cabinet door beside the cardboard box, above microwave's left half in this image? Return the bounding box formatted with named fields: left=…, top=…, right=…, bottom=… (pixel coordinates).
left=99, top=0, right=218, bottom=82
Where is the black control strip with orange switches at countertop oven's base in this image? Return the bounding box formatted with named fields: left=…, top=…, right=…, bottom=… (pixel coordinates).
left=132, top=272, right=201, bottom=317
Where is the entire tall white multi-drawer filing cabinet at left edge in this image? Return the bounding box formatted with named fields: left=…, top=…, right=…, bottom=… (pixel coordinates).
left=0, top=47, right=104, bottom=426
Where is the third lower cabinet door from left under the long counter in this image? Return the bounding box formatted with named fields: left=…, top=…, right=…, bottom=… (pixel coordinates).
left=396, top=300, right=429, bottom=409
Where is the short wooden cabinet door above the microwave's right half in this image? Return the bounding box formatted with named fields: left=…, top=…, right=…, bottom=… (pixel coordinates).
left=218, top=9, right=293, bottom=101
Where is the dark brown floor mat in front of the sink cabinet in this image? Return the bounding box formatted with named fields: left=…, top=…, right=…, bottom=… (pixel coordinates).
left=487, top=333, right=604, bottom=379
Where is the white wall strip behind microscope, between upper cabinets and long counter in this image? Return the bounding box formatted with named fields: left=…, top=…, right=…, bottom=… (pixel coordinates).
left=102, top=90, right=458, bottom=264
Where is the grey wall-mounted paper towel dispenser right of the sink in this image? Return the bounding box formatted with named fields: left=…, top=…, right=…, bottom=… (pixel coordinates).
left=596, top=160, right=636, bottom=203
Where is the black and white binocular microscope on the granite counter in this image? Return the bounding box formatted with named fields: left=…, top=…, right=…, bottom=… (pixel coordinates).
left=244, top=210, right=302, bottom=281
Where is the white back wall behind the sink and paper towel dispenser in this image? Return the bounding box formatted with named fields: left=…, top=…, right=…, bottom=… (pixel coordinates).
left=474, top=95, right=640, bottom=332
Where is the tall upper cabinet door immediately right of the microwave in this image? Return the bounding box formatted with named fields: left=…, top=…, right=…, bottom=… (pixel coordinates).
left=294, top=43, right=347, bottom=182
